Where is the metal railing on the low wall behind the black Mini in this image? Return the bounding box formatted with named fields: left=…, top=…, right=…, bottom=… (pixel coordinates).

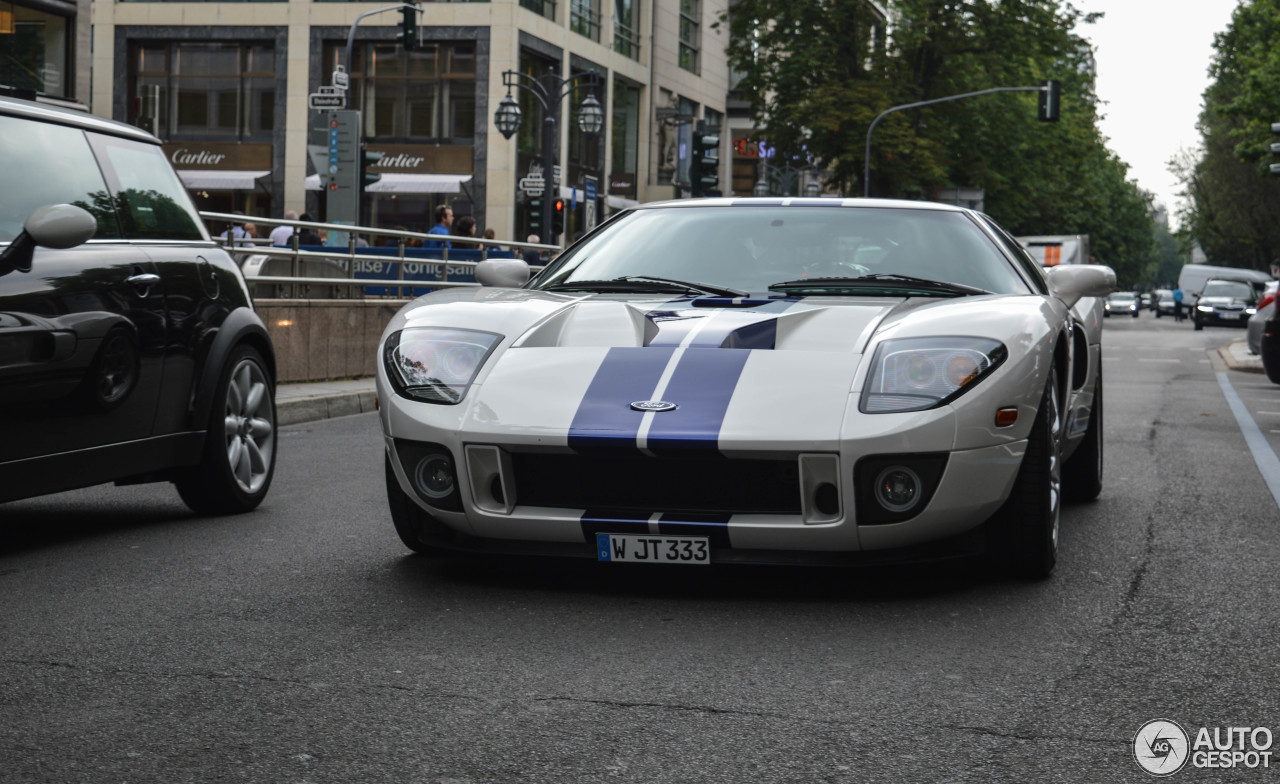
left=200, top=211, right=561, bottom=298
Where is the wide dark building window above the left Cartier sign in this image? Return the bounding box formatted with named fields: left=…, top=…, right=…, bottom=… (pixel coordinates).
left=128, top=41, right=275, bottom=141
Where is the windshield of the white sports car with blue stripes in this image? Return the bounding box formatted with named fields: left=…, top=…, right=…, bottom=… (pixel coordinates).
left=531, top=202, right=1030, bottom=296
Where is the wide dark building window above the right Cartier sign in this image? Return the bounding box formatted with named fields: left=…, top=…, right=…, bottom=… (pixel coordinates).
left=325, top=41, right=476, bottom=145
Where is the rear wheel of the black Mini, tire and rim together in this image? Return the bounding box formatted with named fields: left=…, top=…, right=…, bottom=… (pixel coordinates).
left=174, top=346, right=276, bottom=515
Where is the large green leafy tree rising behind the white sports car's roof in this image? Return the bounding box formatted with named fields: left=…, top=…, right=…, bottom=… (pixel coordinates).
left=726, top=0, right=1155, bottom=284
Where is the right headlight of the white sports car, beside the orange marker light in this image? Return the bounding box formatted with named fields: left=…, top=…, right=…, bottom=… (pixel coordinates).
left=859, top=337, right=1009, bottom=414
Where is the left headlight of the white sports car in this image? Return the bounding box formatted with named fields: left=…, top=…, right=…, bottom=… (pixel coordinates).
left=383, top=327, right=502, bottom=405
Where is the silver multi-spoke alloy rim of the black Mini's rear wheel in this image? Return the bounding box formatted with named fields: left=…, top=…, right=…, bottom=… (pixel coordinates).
left=224, top=359, right=275, bottom=493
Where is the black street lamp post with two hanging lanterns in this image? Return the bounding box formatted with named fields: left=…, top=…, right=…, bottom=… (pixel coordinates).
left=493, top=70, right=604, bottom=245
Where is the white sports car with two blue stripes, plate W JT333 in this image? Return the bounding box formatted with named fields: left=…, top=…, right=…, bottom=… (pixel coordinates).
left=378, top=199, right=1115, bottom=576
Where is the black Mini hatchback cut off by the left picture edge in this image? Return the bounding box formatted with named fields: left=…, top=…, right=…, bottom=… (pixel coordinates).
left=0, top=97, right=276, bottom=514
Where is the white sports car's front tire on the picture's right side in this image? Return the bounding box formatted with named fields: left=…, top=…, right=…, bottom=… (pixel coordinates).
left=987, top=369, right=1062, bottom=580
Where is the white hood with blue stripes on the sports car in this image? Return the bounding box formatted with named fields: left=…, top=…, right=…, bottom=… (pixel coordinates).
left=388, top=290, right=1043, bottom=451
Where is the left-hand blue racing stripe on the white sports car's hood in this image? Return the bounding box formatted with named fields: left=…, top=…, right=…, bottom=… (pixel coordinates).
left=568, top=347, right=675, bottom=451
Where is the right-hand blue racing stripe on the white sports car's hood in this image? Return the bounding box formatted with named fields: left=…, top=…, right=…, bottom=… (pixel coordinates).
left=646, top=348, right=751, bottom=453
